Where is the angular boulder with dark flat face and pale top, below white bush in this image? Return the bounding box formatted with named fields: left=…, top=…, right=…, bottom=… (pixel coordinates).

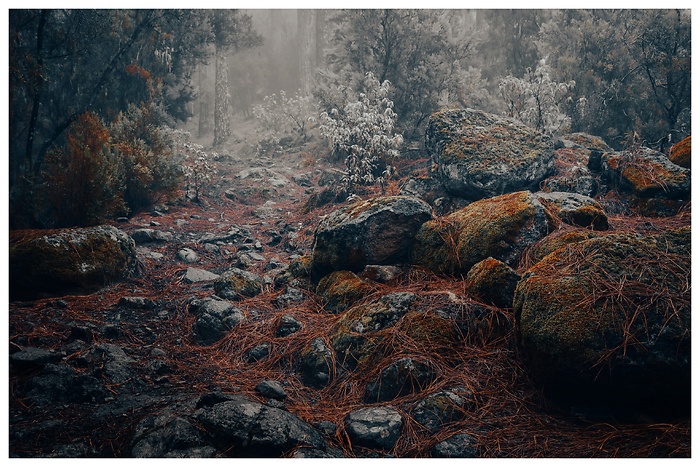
left=312, top=196, right=432, bottom=280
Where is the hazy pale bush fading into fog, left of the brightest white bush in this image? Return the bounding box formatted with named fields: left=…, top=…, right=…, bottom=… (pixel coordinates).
left=253, top=91, right=316, bottom=156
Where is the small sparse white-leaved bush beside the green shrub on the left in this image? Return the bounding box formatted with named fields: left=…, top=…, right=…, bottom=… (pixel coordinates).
left=174, top=130, right=217, bottom=201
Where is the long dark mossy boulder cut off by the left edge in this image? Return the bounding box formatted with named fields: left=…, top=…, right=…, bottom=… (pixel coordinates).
left=9, top=225, right=137, bottom=300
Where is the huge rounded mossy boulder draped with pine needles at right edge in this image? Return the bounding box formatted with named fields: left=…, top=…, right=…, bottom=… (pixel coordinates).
left=514, top=227, right=691, bottom=412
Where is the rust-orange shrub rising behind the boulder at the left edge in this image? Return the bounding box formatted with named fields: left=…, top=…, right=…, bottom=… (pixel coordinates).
left=41, top=112, right=126, bottom=227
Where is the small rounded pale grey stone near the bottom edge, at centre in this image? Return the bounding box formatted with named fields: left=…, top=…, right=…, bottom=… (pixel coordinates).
left=345, top=406, right=403, bottom=449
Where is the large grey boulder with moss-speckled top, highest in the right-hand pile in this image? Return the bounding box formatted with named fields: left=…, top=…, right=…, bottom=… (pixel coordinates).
left=425, top=109, right=554, bottom=200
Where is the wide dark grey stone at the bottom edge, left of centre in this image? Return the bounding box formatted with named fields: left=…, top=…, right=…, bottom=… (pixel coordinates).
left=195, top=395, right=325, bottom=457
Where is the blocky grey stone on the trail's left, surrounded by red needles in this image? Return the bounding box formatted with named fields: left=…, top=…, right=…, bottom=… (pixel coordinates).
left=189, top=297, right=245, bottom=345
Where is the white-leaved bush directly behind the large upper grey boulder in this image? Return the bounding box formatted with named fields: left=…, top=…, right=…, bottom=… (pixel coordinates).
left=498, top=63, right=583, bottom=135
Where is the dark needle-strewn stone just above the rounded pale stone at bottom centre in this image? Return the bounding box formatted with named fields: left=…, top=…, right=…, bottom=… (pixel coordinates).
left=365, top=358, right=437, bottom=402
